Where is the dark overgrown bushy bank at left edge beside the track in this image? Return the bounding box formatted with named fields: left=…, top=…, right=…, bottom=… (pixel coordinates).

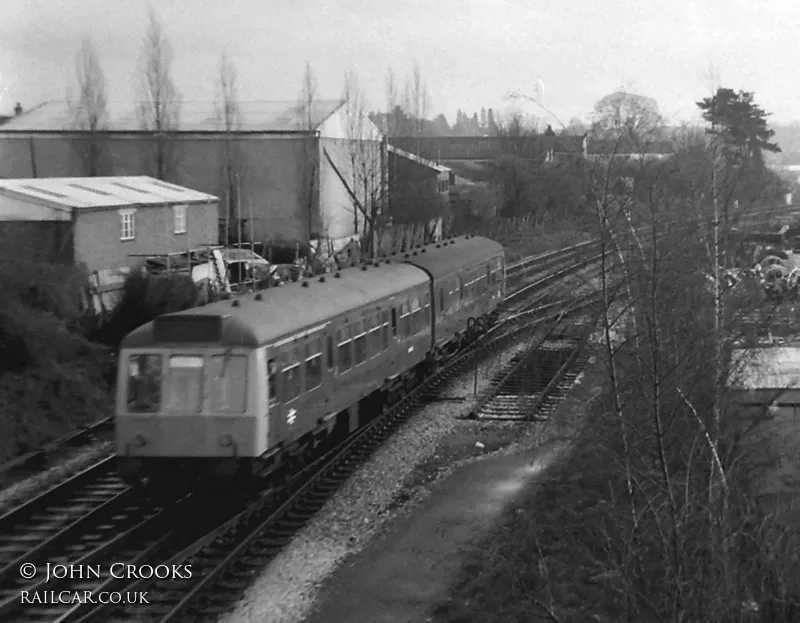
left=0, top=260, right=112, bottom=460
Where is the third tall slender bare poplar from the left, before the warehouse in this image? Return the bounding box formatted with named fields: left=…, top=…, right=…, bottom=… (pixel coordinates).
left=214, top=52, right=242, bottom=243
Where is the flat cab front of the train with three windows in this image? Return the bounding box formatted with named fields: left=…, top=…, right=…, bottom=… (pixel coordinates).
left=115, top=344, right=268, bottom=480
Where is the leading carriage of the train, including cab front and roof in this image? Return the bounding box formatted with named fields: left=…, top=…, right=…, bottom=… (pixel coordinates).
left=115, top=262, right=431, bottom=464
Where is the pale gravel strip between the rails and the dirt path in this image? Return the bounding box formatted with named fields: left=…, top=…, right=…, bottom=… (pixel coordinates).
left=220, top=343, right=540, bottom=623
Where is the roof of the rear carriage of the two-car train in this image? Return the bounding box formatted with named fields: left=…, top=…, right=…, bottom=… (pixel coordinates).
left=403, top=236, right=504, bottom=280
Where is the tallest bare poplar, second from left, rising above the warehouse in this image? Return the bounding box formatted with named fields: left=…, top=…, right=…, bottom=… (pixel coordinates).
left=137, top=10, right=181, bottom=180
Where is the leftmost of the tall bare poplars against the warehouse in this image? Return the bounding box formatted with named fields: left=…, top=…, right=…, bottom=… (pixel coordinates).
left=67, top=37, right=110, bottom=177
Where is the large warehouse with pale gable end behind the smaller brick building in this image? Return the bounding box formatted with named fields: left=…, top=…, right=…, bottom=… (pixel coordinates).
left=0, top=101, right=386, bottom=254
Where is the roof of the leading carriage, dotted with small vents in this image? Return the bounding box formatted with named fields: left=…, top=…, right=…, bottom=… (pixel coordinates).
left=121, top=259, right=429, bottom=348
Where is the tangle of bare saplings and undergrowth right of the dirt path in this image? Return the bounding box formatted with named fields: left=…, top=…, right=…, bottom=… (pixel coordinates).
left=433, top=89, right=800, bottom=623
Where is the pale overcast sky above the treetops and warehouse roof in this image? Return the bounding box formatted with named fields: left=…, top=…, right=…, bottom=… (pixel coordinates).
left=0, top=0, right=800, bottom=125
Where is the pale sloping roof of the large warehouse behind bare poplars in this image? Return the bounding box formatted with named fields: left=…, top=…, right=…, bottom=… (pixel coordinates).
left=0, top=100, right=343, bottom=132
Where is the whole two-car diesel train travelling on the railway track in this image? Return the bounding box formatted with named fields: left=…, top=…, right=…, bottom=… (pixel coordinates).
left=114, top=235, right=506, bottom=488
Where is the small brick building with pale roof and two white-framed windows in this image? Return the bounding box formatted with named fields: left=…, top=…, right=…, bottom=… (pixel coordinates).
left=0, top=177, right=219, bottom=283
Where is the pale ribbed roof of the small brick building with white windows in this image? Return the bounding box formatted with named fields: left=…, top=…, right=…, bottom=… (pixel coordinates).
left=0, top=176, right=218, bottom=209
